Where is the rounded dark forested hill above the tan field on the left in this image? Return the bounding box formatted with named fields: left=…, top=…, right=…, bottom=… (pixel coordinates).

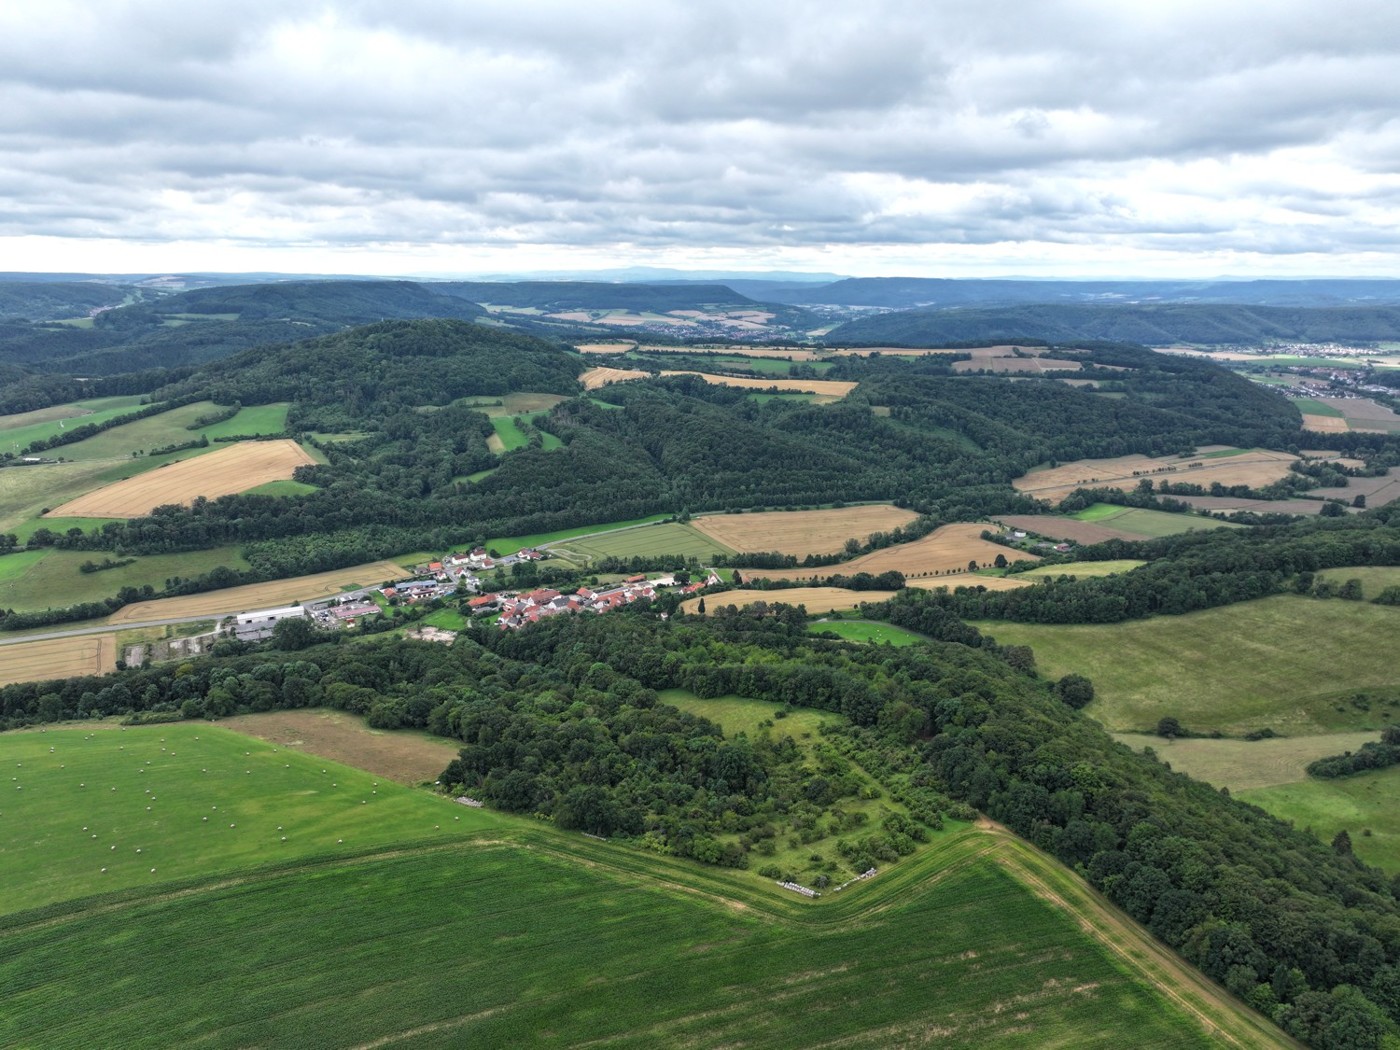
left=160, top=319, right=582, bottom=430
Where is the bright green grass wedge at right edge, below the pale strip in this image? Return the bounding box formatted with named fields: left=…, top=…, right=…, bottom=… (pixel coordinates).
left=1239, top=767, right=1400, bottom=875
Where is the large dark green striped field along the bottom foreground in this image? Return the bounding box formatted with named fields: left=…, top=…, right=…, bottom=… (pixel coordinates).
left=0, top=813, right=1248, bottom=1047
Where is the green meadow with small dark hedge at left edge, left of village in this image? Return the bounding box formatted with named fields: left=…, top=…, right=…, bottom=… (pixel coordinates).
left=0, top=546, right=248, bottom=612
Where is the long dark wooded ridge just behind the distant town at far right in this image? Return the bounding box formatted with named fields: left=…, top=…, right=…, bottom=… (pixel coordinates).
left=827, top=302, right=1400, bottom=346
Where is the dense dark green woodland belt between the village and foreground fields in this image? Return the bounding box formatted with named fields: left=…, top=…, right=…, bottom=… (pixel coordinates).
left=0, top=604, right=1400, bottom=1047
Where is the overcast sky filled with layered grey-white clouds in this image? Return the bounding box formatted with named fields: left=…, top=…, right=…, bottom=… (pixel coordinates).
left=0, top=0, right=1400, bottom=277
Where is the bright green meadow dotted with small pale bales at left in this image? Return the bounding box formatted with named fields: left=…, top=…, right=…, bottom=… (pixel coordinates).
left=0, top=728, right=496, bottom=918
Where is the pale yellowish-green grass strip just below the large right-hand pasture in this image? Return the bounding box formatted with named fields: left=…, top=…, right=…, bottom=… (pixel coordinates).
left=1113, top=732, right=1376, bottom=794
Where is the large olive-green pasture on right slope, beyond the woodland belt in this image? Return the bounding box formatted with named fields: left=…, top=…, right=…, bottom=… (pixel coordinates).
left=977, top=596, right=1400, bottom=735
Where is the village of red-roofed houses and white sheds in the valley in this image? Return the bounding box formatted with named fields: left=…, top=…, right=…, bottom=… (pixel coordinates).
left=223, top=547, right=721, bottom=643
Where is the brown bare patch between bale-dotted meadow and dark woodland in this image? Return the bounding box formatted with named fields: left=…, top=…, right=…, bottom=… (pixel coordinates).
left=220, top=710, right=461, bottom=784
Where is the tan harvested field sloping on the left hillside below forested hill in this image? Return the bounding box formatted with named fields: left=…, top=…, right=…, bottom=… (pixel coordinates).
left=46, top=440, right=316, bottom=518
